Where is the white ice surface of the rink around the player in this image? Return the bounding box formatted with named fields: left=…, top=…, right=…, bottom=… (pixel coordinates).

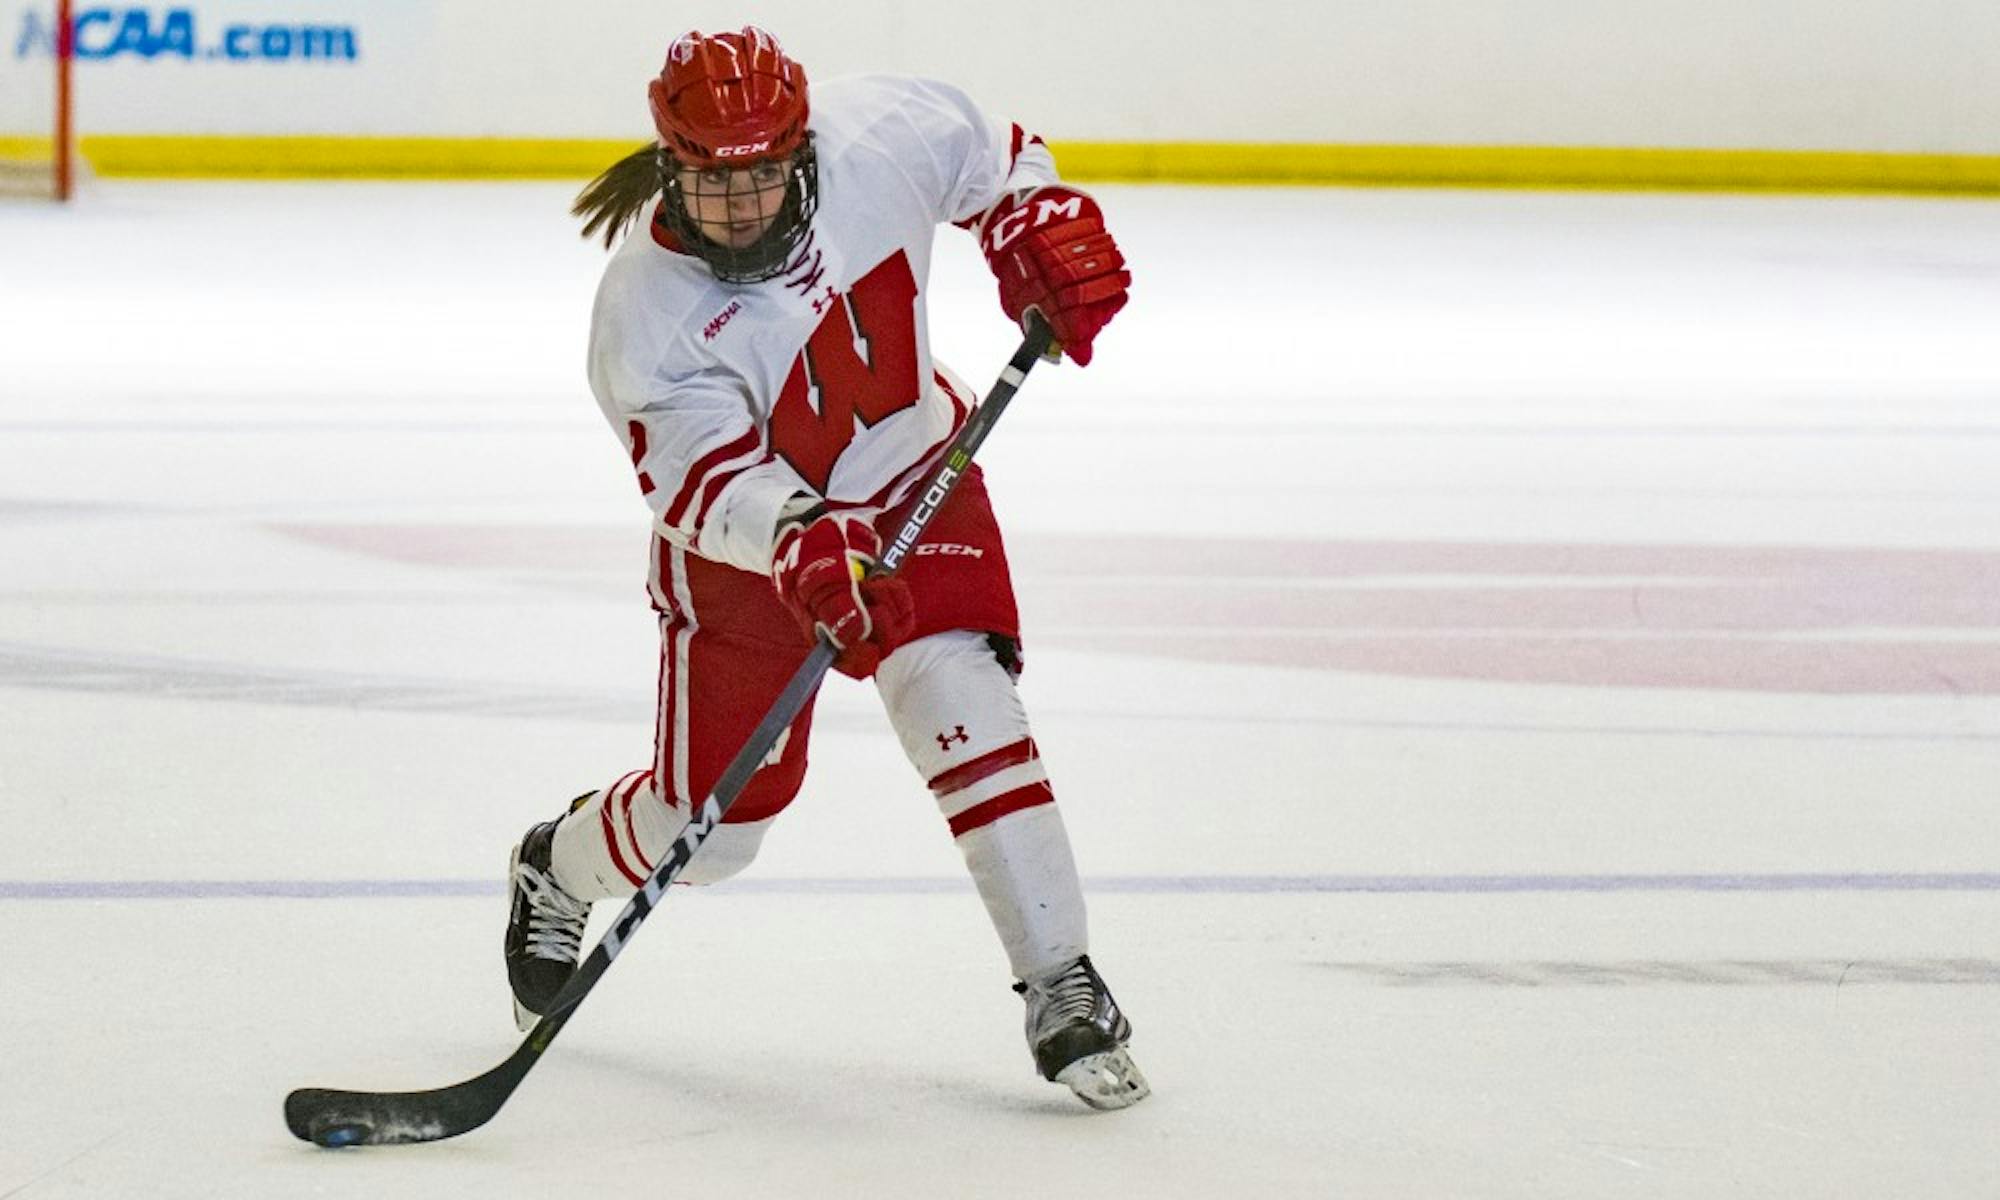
left=0, top=182, right=2000, bottom=1200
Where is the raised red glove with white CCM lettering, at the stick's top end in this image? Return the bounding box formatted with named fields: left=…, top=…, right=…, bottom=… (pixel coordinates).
left=980, top=184, right=1132, bottom=366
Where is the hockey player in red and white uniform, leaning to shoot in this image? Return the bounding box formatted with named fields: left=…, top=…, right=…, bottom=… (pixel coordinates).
left=506, top=28, right=1148, bottom=1108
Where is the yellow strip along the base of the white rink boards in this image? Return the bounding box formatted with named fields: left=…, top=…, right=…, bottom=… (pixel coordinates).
left=50, top=134, right=2000, bottom=196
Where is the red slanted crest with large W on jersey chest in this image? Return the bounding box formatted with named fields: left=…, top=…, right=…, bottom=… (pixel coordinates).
left=770, top=250, right=922, bottom=496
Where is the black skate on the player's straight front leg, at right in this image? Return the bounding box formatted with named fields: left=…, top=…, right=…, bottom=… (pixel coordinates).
left=1014, top=954, right=1152, bottom=1108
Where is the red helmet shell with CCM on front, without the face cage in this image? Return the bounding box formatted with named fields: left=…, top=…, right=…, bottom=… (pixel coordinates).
left=646, top=26, right=808, bottom=168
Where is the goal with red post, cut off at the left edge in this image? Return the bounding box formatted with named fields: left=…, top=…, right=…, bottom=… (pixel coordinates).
left=0, top=0, right=76, bottom=200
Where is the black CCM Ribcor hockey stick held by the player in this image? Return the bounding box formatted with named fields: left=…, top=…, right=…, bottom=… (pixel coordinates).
left=284, top=318, right=1052, bottom=1146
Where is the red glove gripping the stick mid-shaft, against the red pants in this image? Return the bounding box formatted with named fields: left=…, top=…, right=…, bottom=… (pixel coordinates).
left=770, top=512, right=916, bottom=680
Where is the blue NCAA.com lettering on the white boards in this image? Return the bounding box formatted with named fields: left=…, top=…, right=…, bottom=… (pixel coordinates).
left=14, top=6, right=360, bottom=62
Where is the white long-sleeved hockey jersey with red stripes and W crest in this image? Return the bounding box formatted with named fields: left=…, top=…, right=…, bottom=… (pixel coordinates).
left=590, top=76, right=1056, bottom=582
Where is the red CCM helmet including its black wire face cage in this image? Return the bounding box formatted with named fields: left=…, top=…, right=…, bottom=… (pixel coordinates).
left=646, top=26, right=820, bottom=284
